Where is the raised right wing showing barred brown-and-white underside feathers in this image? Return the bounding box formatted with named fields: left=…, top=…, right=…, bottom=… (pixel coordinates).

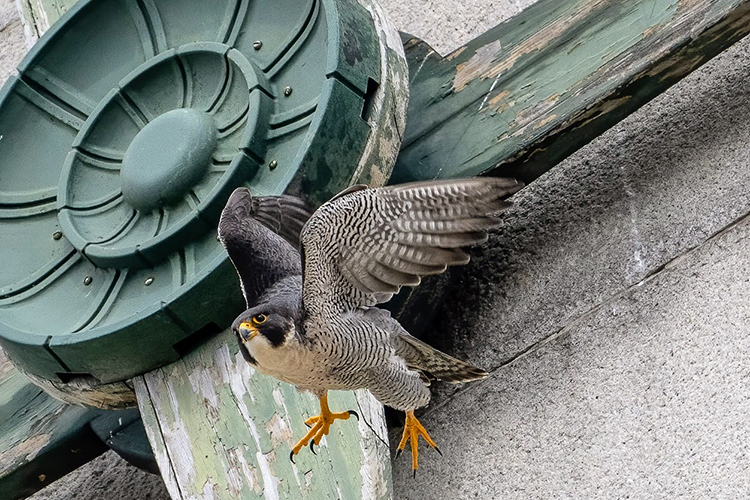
left=302, top=178, right=523, bottom=314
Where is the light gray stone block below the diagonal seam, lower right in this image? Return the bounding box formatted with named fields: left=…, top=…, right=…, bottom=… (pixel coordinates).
left=395, top=211, right=750, bottom=500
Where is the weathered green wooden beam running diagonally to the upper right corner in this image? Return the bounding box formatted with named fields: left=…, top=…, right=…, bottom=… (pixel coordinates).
left=390, top=0, right=750, bottom=183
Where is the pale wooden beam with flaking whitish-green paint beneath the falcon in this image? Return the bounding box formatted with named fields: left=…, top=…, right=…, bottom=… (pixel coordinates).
left=134, top=330, right=391, bottom=500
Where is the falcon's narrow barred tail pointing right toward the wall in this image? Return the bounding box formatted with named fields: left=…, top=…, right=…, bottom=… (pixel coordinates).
left=397, top=334, right=489, bottom=384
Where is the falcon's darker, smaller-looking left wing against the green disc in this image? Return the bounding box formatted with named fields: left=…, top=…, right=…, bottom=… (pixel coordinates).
left=219, top=188, right=311, bottom=307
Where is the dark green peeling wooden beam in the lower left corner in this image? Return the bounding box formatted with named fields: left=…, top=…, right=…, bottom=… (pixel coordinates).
left=0, top=349, right=107, bottom=500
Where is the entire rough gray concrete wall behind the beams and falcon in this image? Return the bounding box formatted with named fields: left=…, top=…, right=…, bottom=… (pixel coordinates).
left=0, top=0, right=750, bottom=500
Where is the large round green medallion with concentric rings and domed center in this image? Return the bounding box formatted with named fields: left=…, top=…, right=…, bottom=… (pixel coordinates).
left=0, top=0, right=408, bottom=407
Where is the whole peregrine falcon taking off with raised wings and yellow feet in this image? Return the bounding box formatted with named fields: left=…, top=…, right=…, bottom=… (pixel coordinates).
left=219, top=178, right=523, bottom=473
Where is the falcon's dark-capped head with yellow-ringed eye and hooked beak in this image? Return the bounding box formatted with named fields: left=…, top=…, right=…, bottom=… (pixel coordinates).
left=232, top=304, right=295, bottom=348
